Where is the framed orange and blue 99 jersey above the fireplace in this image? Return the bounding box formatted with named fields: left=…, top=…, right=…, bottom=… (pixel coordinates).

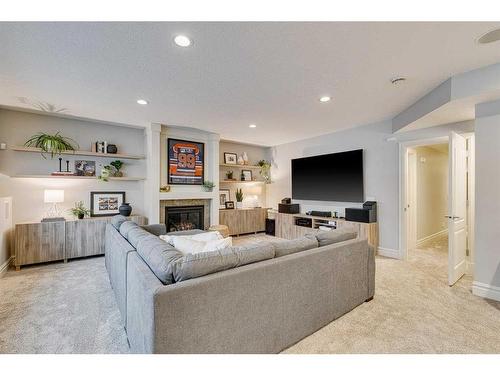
left=167, top=138, right=205, bottom=185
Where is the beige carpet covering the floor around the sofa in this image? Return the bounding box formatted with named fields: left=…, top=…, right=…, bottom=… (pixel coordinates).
left=0, top=235, right=500, bottom=353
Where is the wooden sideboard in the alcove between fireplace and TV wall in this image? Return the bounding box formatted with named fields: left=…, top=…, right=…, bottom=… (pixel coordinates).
left=219, top=208, right=267, bottom=236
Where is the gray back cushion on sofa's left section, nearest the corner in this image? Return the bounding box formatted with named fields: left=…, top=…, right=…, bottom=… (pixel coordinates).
left=137, top=233, right=182, bottom=284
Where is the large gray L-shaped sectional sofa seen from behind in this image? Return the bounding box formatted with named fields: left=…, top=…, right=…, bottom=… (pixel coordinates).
left=105, top=216, right=375, bottom=353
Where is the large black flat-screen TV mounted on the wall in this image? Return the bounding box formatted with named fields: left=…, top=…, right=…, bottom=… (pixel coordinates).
left=292, top=150, right=364, bottom=202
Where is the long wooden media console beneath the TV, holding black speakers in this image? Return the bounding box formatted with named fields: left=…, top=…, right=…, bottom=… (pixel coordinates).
left=273, top=212, right=378, bottom=249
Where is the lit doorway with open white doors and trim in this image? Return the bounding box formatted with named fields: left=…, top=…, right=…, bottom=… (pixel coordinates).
left=400, top=132, right=474, bottom=286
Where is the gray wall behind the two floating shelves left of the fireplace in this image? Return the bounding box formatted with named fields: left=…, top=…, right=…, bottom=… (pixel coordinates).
left=0, top=109, right=146, bottom=223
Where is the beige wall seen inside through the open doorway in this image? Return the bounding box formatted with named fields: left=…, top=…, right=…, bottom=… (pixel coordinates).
left=415, top=145, right=448, bottom=241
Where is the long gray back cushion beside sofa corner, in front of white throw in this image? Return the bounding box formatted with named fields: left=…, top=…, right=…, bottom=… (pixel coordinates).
left=173, top=243, right=274, bottom=281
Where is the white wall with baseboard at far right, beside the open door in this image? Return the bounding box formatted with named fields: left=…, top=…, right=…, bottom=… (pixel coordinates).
left=473, top=101, right=500, bottom=300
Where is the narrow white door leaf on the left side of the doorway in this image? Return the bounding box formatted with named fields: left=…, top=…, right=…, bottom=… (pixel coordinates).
left=406, top=148, right=417, bottom=251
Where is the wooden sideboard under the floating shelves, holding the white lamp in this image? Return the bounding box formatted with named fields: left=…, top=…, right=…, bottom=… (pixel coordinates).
left=14, top=215, right=147, bottom=271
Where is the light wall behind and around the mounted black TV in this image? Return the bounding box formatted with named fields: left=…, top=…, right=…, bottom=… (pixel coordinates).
left=267, top=121, right=474, bottom=254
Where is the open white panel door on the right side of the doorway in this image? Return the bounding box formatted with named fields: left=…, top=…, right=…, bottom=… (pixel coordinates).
left=447, top=132, right=467, bottom=286
